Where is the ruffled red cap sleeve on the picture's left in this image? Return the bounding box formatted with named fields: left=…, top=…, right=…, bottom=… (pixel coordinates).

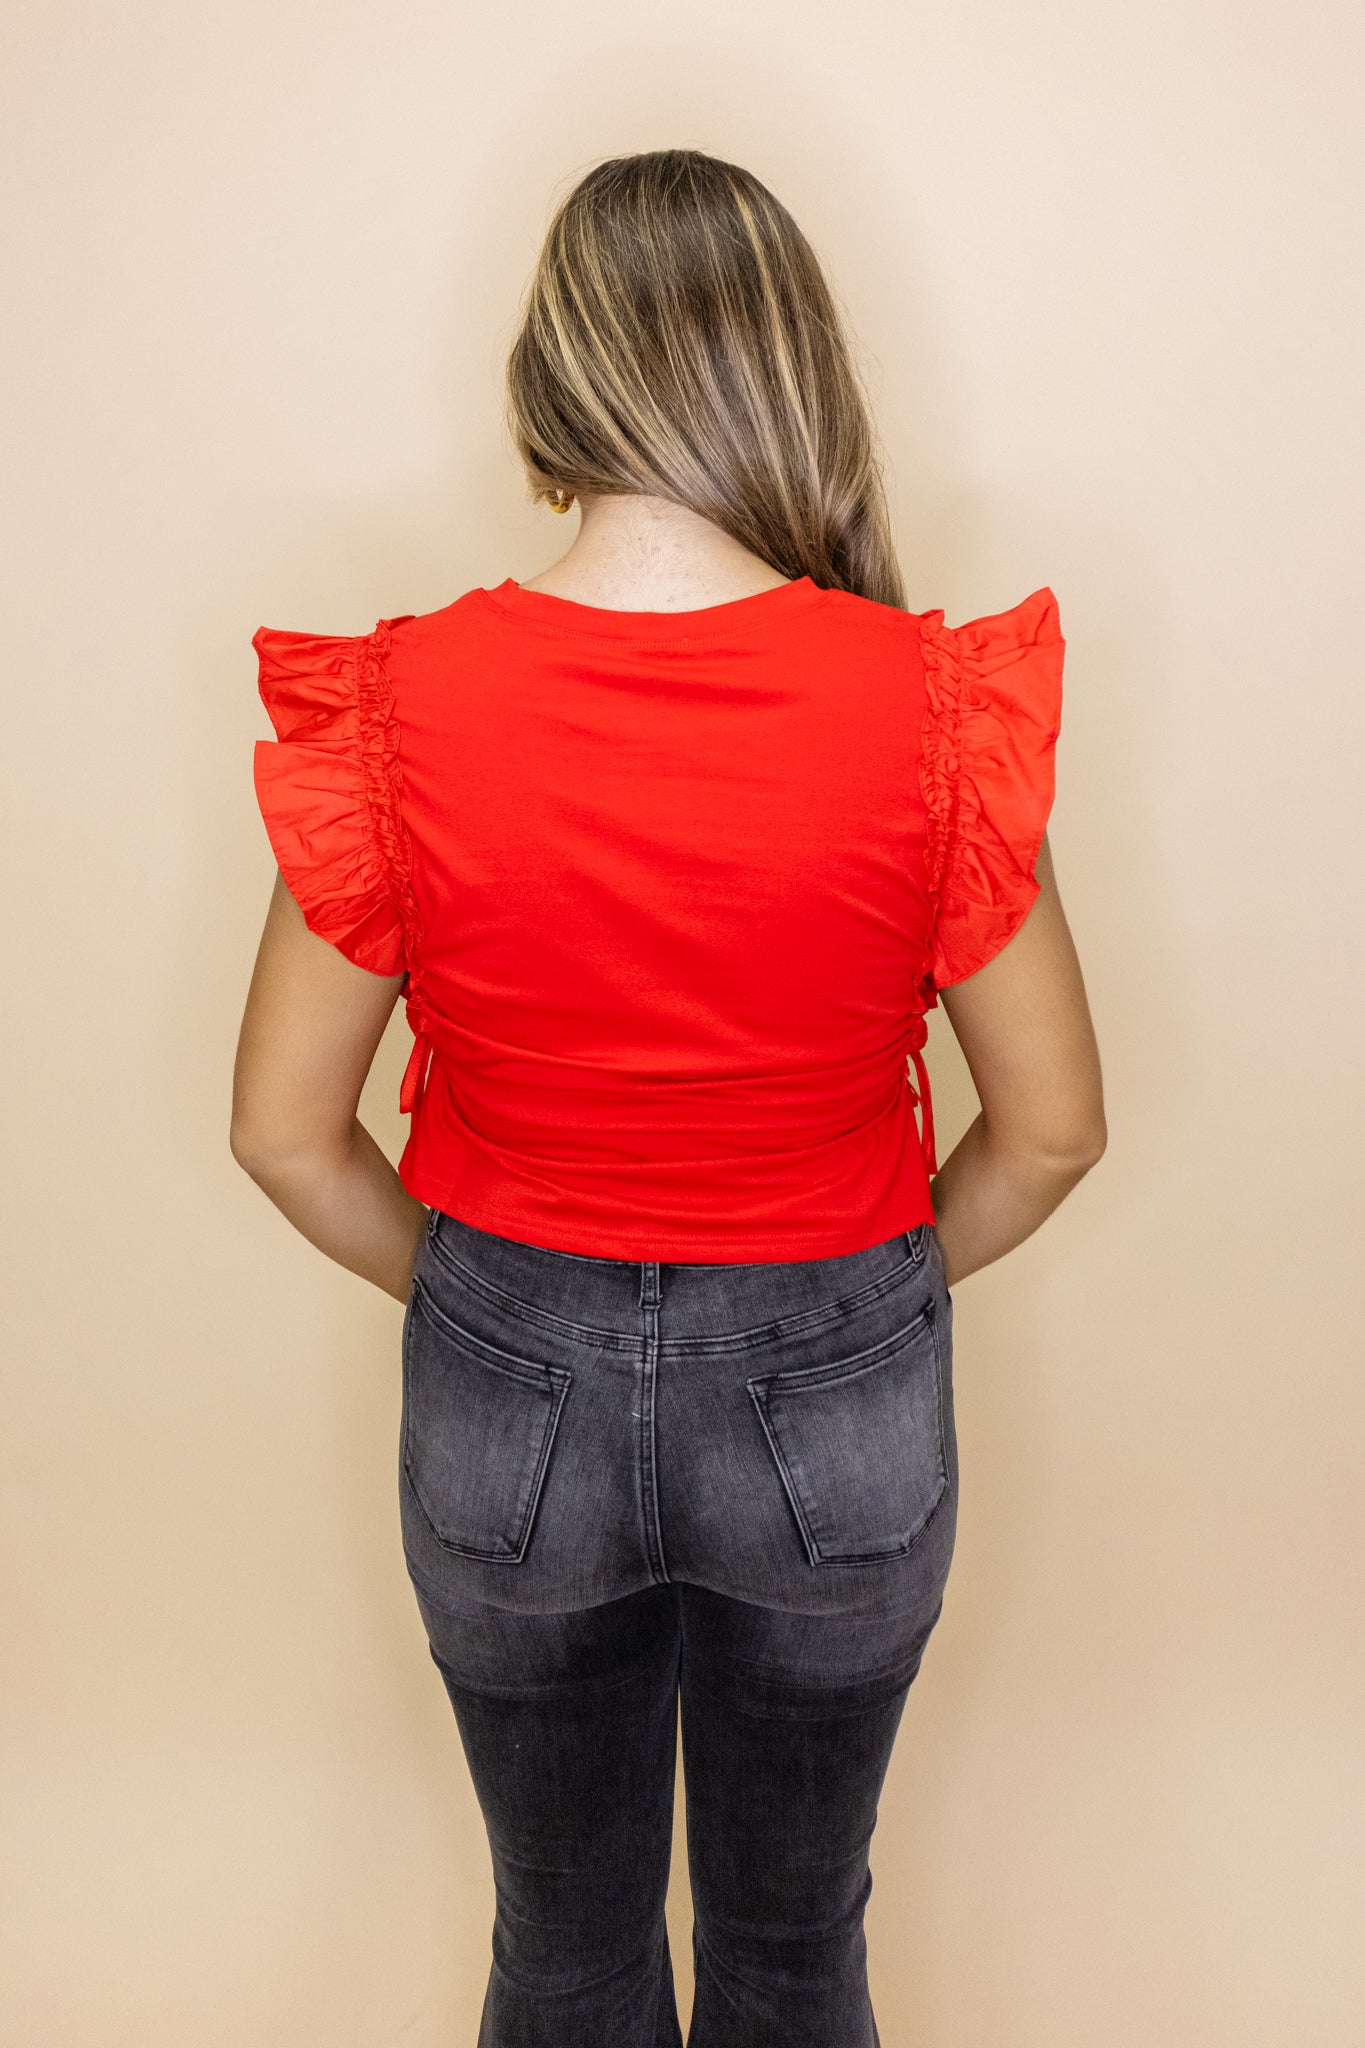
left=252, top=621, right=413, bottom=975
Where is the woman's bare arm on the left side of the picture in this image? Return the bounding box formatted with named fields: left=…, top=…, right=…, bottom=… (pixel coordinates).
left=231, top=874, right=430, bottom=1303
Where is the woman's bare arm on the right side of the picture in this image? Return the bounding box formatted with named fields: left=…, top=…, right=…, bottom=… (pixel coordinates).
left=933, top=838, right=1105, bottom=1286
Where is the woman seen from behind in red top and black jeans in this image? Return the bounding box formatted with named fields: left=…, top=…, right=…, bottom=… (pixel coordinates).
left=233, top=150, right=1105, bottom=2048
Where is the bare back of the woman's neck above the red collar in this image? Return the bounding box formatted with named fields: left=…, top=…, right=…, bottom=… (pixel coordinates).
left=522, top=492, right=790, bottom=612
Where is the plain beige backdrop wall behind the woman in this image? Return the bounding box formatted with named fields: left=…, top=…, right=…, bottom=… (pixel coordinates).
left=2, top=0, right=1365, bottom=2048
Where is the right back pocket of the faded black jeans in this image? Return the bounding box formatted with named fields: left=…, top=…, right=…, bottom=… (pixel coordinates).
left=747, top=1303, right=948, bottom=1565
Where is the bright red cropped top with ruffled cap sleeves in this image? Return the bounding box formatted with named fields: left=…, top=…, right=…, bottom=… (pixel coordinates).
left=254, top=575, right=1064, bottom=1264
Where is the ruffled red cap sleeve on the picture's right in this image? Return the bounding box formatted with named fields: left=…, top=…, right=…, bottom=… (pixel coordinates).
left=921, top=588, right=1066, bottom=989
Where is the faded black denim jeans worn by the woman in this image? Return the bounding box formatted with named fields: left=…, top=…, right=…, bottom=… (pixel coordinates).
left=399, top=1210, right=958, bottom=2048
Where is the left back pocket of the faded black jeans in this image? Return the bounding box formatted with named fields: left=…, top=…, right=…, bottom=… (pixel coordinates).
left=403, top=1280, right=573, bottom=1565
